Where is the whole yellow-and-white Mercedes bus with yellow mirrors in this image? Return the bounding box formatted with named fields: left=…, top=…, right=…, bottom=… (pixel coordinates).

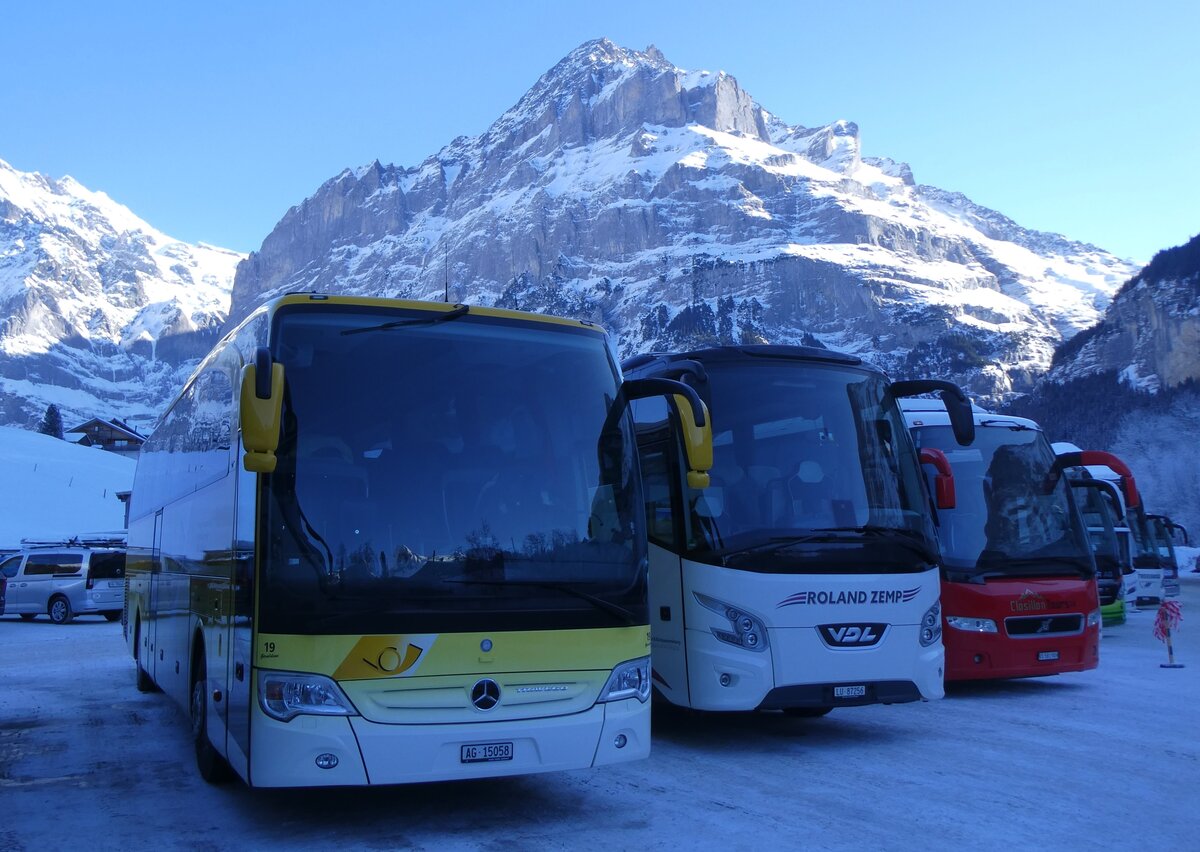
left=124, top=294, right=712, bottom=787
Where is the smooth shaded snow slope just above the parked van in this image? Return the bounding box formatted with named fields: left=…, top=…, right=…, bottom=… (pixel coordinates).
left=0, top=426, right=134, bottom=548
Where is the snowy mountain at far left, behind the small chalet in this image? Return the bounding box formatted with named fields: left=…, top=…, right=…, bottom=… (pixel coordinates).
left=0, top=161, right=242, bottom=427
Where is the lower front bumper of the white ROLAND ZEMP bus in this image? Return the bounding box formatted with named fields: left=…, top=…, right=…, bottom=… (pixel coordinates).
left=688, top=625, right=944, bottom=710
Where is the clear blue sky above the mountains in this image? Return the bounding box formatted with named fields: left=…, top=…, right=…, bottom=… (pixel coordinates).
left=0, top=0, right=1200, bottom=260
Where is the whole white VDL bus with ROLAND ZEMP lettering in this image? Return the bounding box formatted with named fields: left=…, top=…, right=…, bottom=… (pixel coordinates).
left=624, top=346, right=971, bottom=716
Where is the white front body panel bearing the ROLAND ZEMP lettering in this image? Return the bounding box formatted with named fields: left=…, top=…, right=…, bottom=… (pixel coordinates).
left=650, top=544, right=944, bottom=710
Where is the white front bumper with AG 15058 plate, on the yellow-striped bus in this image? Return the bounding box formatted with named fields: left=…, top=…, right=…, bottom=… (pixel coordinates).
left=250, top=698, right=650, bottom=787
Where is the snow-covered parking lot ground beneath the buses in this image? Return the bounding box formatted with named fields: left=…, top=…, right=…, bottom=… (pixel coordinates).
left=0, top=572, right=1200, bottom=852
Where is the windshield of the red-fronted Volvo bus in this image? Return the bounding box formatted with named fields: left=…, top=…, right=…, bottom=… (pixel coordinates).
left=914, top=426, right=1096, bottom=580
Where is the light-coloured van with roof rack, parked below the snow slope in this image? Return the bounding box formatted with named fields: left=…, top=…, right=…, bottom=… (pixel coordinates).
left=0, top=544, right=125, bottom=624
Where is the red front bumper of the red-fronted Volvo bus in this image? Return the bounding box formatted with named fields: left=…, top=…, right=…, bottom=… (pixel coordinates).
left=943, top=628, right=1100, bottom=680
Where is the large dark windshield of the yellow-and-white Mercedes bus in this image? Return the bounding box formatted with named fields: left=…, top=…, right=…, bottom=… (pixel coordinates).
left=259, top=307, right=647, bottom=634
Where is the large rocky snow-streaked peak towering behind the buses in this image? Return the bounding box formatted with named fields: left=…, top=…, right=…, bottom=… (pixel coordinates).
left=229, top=40, right=1136, bottom=400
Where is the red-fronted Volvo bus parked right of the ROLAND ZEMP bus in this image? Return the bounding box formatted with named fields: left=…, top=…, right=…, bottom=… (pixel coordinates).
left=904, top=400, right=1100, bottom=680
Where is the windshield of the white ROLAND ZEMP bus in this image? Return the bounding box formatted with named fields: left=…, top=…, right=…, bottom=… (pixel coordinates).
left=688, top=359, right=937, bottom=574
